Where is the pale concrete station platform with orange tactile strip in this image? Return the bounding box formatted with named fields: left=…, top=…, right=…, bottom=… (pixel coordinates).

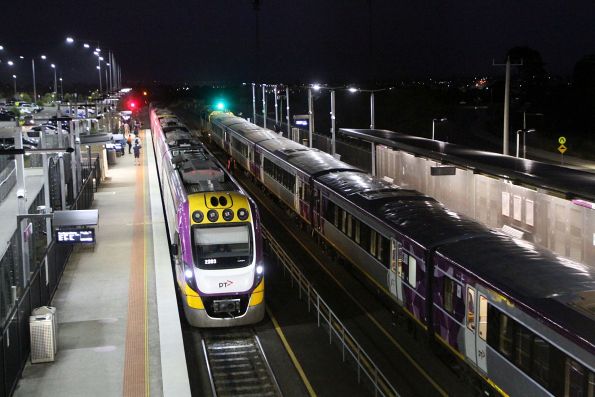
left=14, top=130, right=190, bottom=396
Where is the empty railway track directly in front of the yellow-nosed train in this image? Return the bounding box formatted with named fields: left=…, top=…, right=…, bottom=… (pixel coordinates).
left=202, top=329, right=282, bottom=397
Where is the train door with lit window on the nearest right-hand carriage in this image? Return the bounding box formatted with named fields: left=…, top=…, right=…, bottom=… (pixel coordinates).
left=465, top=285, right=488, bottom=372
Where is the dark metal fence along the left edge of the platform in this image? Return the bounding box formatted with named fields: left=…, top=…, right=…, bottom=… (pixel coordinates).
left=0, top=157, right=100, bottom=397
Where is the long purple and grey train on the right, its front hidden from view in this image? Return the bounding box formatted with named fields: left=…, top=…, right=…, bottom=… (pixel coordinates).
left=209, top=112, right=595, bottom=397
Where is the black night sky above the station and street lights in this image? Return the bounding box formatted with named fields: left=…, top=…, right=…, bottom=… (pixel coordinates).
left=0, top=0, right=595, bottom=83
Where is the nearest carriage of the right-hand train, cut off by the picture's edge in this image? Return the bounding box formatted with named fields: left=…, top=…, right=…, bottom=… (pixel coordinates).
left=434, top=234, right=595, bottom=396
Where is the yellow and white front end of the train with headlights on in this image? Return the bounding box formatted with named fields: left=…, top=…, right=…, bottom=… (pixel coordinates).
left=174, top=191, right=265, bottom=327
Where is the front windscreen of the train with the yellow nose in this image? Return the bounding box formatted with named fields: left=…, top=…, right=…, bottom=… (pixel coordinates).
left=192, top=224, right=252, bottom=269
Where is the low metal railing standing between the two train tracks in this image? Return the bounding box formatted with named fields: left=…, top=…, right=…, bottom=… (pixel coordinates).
left=262, top=228, right=399, bottom=397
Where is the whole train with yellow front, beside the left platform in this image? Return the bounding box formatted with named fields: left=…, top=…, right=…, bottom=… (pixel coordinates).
left=150, top=109, right=265, bottom=327
